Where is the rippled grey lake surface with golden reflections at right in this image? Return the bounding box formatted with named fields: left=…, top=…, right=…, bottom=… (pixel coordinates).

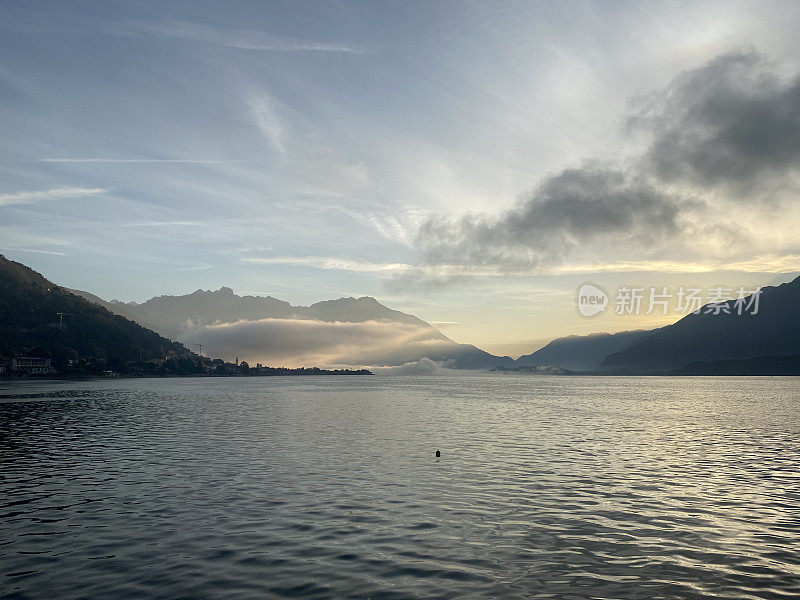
left=0, top=374, right=800, bottom=600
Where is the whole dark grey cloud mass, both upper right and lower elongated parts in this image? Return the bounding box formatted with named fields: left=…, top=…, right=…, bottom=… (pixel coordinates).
left=410, top=52, right=800, bottom=278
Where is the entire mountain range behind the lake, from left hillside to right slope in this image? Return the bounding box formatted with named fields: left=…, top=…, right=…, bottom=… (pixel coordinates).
left=0, top=255, right=800, bottom=375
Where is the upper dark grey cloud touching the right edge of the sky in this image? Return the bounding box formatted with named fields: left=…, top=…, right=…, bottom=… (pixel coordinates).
left=631, top=51, right=800, bottom=192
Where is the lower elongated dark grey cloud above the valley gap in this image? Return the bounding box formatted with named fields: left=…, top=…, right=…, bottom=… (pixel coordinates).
left=418, top=165, right=697, bottom=268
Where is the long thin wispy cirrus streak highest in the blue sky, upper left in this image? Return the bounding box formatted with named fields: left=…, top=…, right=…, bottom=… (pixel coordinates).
left=105, top=20, right=370, bottom=54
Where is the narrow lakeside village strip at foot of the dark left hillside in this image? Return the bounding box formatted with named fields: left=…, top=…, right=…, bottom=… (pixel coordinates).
left=0, top=353, right=373, bottom=379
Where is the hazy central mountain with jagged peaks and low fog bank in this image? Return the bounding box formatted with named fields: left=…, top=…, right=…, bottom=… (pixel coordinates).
left=72, top=287, right=513, bottom=369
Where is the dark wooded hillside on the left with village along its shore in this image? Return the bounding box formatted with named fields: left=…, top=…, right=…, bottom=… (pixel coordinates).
left=0, top=298, right=372, bottom=379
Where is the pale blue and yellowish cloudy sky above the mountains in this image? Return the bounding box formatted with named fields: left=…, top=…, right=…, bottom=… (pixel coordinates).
left=0, top=1, right=800, bottom=355
